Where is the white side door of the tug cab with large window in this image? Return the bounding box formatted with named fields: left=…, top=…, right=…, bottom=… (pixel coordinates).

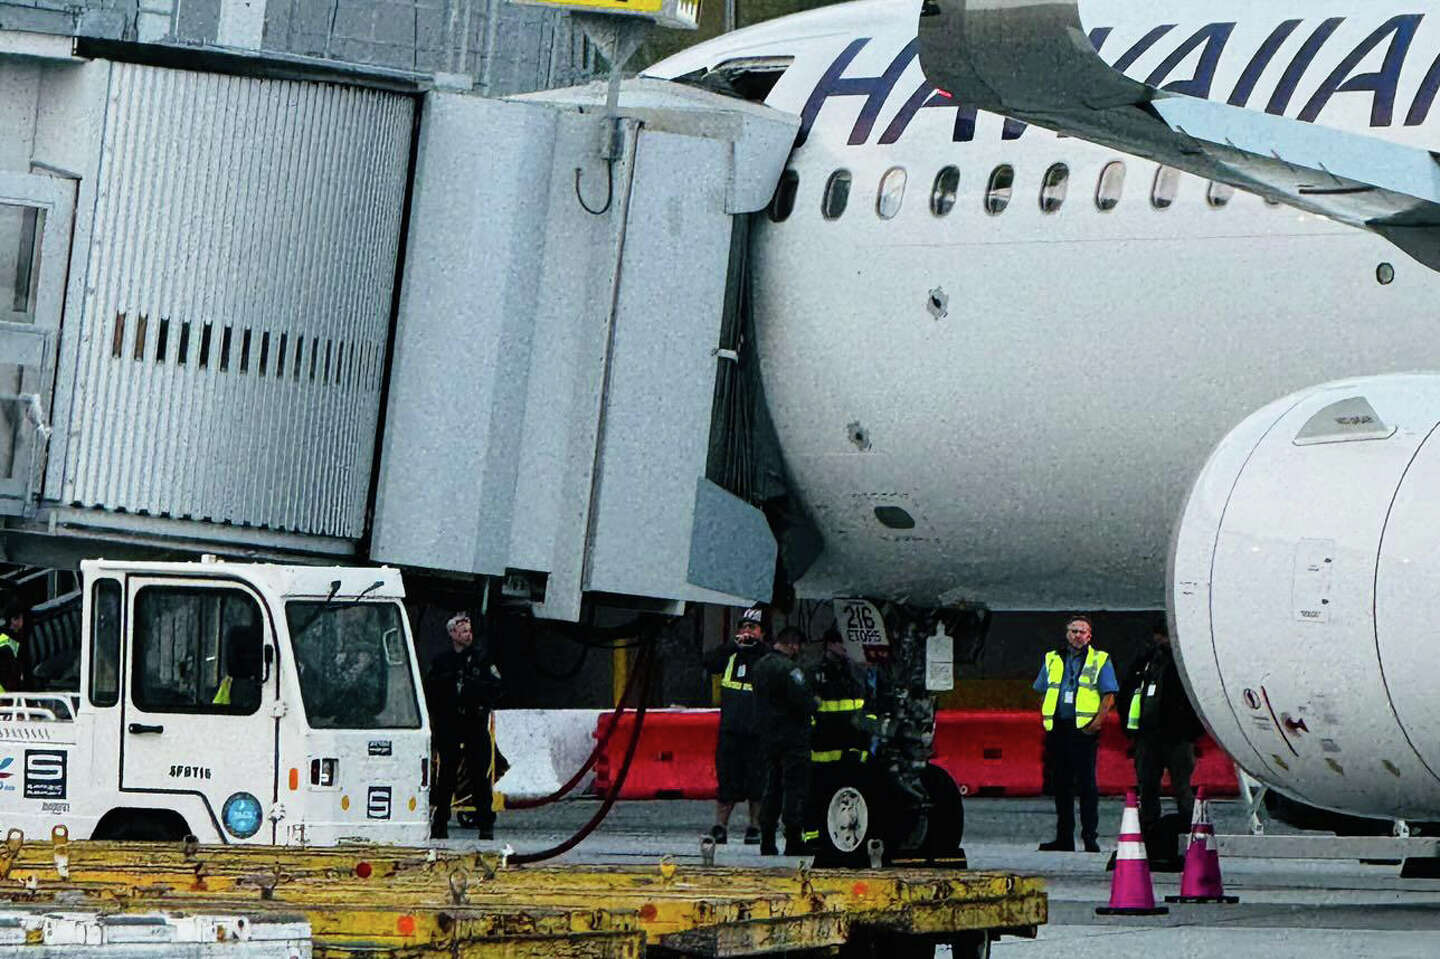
left=120, top=576, right=279, bottom=842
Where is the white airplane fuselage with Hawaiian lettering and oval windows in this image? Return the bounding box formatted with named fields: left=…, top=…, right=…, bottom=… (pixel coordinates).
left=647, top=0, right=1440, bottom=609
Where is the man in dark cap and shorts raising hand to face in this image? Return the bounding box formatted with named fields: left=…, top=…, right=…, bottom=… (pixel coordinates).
left=706, top=606, right=768, bottom=845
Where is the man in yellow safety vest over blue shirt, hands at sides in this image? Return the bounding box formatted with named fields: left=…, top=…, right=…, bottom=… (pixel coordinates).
left=1034, top=616, right=1120, bottom=852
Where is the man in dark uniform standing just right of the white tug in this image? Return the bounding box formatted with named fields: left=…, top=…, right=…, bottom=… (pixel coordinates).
left=425, top=612, right=500, bottom=839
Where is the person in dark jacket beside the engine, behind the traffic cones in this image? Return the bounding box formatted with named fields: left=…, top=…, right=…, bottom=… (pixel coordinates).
left=1120, top=621, right=1204, bottom=870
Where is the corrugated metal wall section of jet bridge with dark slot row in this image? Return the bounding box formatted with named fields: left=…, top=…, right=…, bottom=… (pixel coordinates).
left=62, top=63, right=413, bottom=537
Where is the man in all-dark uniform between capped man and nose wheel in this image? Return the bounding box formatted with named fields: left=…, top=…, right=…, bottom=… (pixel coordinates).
left=755, top=626, right=819, bottom=855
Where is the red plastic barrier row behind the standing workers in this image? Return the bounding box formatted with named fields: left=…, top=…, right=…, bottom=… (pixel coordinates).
left=595, top=710, right=1240, bottom=799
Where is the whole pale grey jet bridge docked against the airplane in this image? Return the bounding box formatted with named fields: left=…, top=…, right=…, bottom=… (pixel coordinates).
left=0, top=35, right=798, bottom=621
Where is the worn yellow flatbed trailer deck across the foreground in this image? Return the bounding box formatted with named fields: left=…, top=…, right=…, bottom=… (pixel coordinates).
left=0, top=832, right=1047, bottom=959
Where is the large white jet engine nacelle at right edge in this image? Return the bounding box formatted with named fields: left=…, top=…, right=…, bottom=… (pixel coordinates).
left=1168, top=374, right=1440, bottom=819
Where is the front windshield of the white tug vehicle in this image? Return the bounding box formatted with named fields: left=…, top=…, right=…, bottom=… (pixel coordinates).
left=285, top=600, right=420, bottom=729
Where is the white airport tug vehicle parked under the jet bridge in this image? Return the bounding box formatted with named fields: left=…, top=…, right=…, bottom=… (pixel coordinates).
left=0, top=557, right=429, bottom=845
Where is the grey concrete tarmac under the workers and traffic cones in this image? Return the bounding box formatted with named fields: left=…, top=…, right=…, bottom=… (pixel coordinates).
left=448, top=798, right=1440, bottom=959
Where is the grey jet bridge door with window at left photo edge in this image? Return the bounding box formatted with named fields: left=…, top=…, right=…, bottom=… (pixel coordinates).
left=0, top=173, right=75, bottom=515
